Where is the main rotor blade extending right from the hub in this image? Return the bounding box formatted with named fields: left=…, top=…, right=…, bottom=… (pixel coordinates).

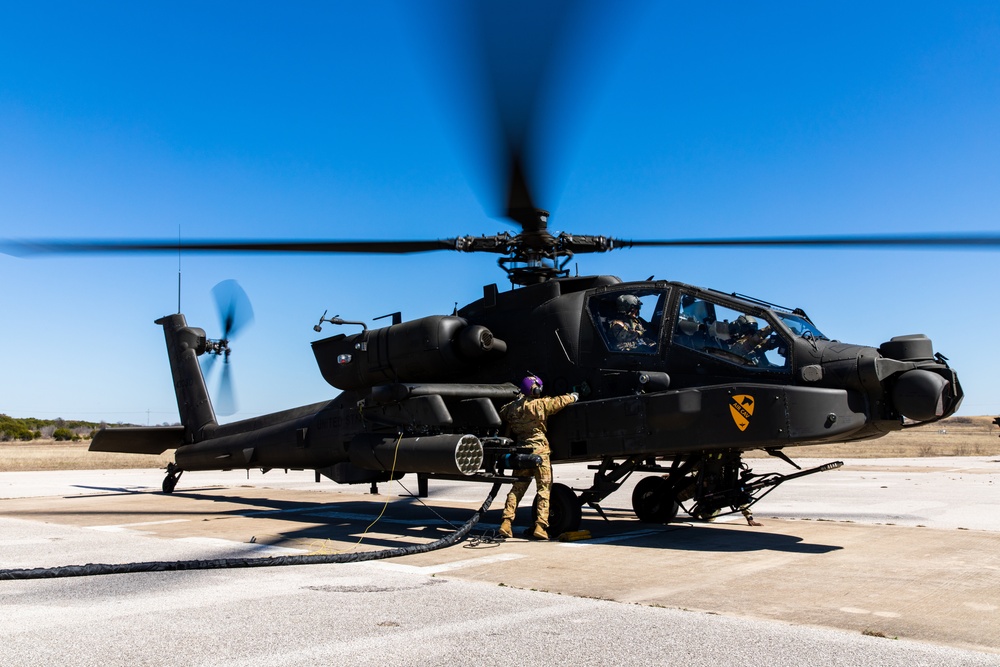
left=612, top=232, right=1000, bottom=250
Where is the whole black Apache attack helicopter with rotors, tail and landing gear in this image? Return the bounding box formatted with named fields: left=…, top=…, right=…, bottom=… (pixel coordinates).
left=7, top=1, right=998, bottom=534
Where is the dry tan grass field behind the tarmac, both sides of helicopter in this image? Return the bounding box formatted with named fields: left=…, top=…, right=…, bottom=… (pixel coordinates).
left=0, top=417, right=1000, bottom=472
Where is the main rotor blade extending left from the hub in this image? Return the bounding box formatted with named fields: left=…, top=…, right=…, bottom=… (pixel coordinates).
left=0, top=239, right=456, bottom=257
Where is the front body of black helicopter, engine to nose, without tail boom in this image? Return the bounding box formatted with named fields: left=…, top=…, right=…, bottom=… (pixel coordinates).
left=306, top=276, right=962, bottom=460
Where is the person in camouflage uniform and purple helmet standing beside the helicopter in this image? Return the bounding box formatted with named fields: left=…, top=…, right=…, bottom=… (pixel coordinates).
left=500, top=375, right=579, bottom=540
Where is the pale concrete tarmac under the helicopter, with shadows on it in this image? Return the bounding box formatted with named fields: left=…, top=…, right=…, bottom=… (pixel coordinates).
left=0, top=458, right=1000, bottom=665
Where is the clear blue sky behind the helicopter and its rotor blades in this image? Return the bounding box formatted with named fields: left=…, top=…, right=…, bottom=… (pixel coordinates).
left=0, top=1, right=1000, bottom=423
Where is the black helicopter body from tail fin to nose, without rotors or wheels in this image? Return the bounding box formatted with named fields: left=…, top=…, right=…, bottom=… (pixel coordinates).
left=92, top=276, right=962, bottom=512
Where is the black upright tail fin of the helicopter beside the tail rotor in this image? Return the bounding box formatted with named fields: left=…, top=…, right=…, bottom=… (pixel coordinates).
left=156, top=313, right=218, bottom=443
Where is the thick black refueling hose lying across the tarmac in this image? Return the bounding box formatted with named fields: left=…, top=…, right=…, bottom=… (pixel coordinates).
left=0, top=482, right=502, bottom=580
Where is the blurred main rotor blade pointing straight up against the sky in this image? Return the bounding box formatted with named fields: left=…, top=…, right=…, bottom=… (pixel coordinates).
left=424, top=0, right=645, bottom=233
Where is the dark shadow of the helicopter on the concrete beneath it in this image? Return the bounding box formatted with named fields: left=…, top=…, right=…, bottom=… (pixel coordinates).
left=47, top=486, right=842, bottom=554
